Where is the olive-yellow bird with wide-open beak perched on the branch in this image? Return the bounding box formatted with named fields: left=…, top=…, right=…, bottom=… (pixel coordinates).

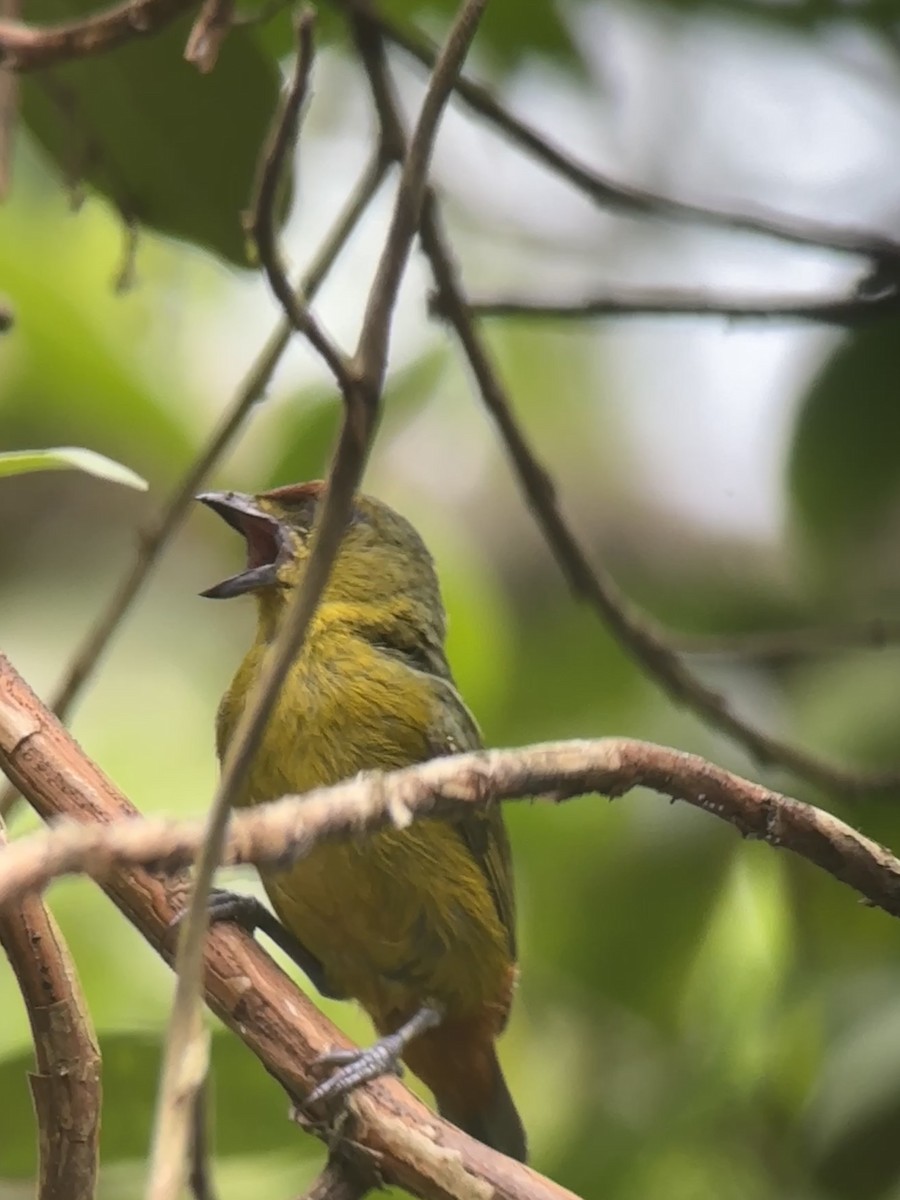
left=197, top=481, right=527, bottom=1162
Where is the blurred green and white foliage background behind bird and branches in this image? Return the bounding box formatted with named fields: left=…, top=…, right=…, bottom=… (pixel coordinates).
left=0, top=0, right=900, bottom=1200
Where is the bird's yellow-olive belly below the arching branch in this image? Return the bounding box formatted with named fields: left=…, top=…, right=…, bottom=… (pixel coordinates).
left=262, top=821, right=512, bottom=1025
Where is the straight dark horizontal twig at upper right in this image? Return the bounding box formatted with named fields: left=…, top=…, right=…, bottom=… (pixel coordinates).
left=460, top=277, right=900, bottom=325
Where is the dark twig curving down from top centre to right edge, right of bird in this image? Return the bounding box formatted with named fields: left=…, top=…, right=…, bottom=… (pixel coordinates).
left=421, top=194, right=900, bottom=796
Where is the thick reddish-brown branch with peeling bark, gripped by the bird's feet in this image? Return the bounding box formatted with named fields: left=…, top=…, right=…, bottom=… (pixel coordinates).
left=0, top=655, right=574, bottom=1200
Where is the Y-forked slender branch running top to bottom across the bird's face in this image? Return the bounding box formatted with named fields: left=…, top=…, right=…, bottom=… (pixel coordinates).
left=148, top=0, right=487, bottom=1200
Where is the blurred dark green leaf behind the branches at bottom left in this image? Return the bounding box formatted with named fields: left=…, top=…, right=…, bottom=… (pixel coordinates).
left=0, top=1031, right=304, bottom=1178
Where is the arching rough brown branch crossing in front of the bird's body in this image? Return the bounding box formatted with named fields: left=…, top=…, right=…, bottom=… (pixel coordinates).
left=0, top=667, right=900, bottom=917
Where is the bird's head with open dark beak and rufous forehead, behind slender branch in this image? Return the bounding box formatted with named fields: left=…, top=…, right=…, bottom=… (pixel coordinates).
left=197, top=481, right=444, bottom=641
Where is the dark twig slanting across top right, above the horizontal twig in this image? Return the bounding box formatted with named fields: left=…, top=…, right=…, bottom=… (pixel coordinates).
left=337, top=0, right=900, bottom=263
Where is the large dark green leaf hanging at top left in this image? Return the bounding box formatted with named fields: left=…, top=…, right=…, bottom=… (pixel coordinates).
left=22, top=0, right=280, bottom=265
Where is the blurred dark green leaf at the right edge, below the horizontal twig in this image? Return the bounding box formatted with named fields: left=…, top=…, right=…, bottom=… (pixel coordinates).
left=788, top=322, right=900, bottom=570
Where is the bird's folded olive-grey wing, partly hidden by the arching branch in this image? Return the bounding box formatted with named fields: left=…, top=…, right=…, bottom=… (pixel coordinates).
left=428, top=677, right=516, bottom=959
